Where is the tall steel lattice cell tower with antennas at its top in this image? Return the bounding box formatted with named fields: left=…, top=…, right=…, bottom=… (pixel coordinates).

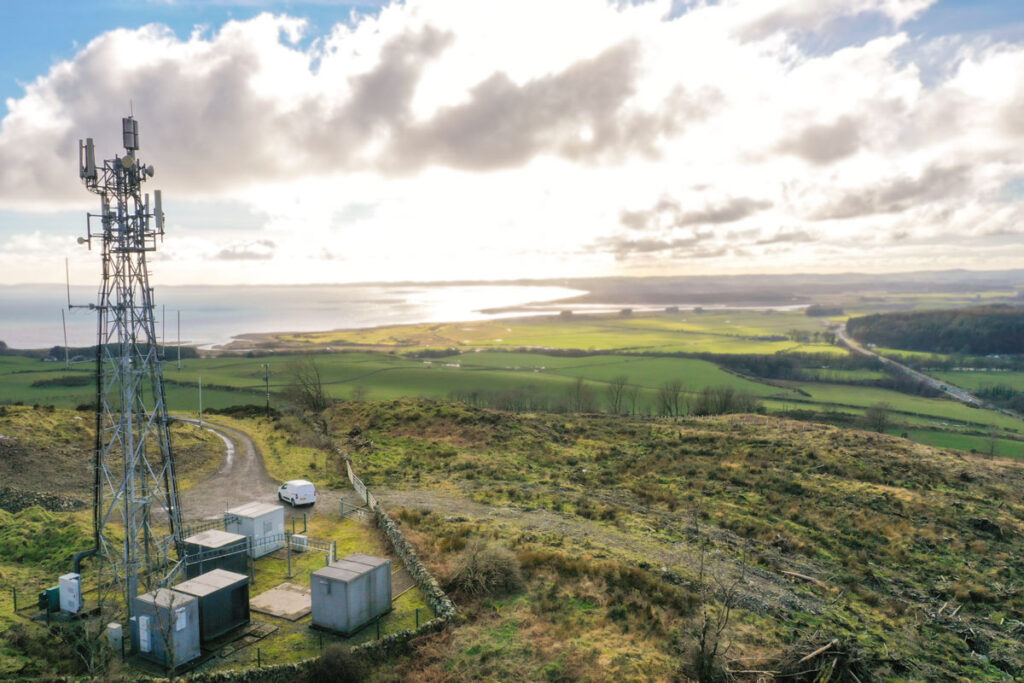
left=79, top=117, right=182, bottom=616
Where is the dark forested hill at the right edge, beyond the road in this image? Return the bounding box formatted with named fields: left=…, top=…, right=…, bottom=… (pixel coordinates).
left=846, top=306, right=1024, bottom=355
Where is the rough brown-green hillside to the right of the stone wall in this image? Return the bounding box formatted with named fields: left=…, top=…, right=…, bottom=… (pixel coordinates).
left=319, top=401, right=1024, bottom=681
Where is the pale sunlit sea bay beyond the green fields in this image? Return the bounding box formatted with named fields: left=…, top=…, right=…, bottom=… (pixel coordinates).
left=0, top=284, right=586, bottom=348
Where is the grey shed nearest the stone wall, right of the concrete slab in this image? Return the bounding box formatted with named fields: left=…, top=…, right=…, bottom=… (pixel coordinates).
left=310, top=555, right=391, bottom=636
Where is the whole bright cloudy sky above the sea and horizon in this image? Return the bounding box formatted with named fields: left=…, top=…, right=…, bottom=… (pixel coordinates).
left=0, top=0, right=1024, bottom=285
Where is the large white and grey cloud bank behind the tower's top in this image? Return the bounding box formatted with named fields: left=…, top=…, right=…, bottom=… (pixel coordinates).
left=0, top=5, right=700, bottom=206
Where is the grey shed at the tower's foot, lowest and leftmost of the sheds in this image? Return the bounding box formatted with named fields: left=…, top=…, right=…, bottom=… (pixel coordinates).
left=129, top=588, right=202, bottom=669
